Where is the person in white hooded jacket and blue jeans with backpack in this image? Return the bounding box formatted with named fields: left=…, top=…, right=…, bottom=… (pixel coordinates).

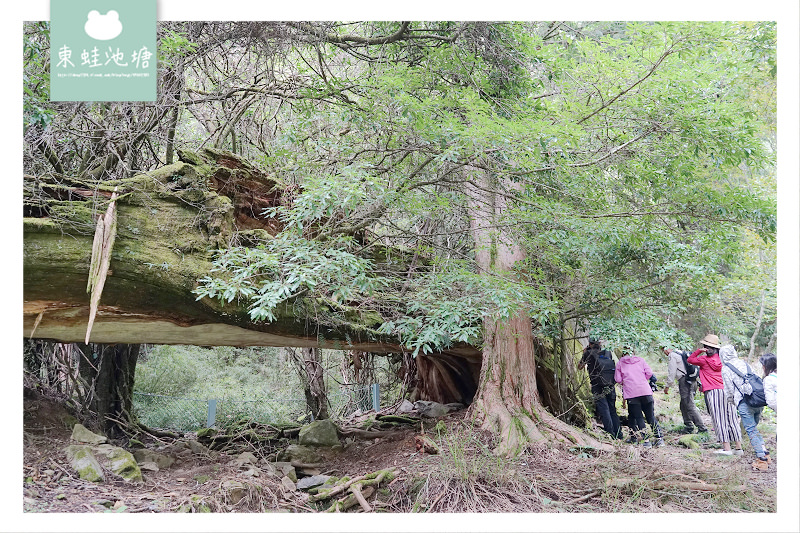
left=719, top=344, right=771, bottom=471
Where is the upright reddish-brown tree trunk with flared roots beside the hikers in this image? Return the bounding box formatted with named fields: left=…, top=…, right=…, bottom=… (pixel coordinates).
left=468, top=171, right=599, bottom=455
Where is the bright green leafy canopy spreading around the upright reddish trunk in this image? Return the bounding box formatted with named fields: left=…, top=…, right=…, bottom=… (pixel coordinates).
left=189, top=22, right=776, bottom=360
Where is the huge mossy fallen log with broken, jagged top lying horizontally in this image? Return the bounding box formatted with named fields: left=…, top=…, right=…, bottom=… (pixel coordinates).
left=23, top=149, right=481, bottom=403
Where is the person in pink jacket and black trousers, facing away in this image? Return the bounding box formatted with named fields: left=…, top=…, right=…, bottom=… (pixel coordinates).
left=614, top=346, right=664, bottom=448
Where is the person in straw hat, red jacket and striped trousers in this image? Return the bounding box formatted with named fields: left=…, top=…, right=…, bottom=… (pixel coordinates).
left=686, top=333, right=744, bottom=455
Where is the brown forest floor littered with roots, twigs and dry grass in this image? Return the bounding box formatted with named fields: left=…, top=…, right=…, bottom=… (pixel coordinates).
left=22, top=390, right=778, bottom=513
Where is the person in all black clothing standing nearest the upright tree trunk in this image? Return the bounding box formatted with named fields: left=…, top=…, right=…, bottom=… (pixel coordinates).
left=579, top=339, right=622, bottom=439
